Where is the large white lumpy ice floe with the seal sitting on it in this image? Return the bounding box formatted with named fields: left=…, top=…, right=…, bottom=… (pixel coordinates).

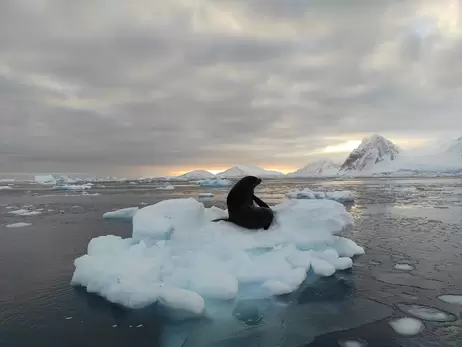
left=71, top=198, right=364, bottom=316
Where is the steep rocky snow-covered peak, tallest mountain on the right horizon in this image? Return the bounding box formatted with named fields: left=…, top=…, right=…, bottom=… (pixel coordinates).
left=340, top=134, right=401, bottom=173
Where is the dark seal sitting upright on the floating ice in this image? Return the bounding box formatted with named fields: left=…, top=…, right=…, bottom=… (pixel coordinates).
left=212, top=176, right=274, bottom=230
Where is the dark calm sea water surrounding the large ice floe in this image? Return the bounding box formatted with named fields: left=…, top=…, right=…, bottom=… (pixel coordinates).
left=0, top=179, right=462, bottom=347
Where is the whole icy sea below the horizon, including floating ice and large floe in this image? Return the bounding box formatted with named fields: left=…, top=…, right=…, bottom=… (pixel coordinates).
left=0, top=178, right=462, bottom=347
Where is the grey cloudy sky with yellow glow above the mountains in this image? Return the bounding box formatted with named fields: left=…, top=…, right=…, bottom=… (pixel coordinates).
left=0, top=0, right=462, bottom=175
